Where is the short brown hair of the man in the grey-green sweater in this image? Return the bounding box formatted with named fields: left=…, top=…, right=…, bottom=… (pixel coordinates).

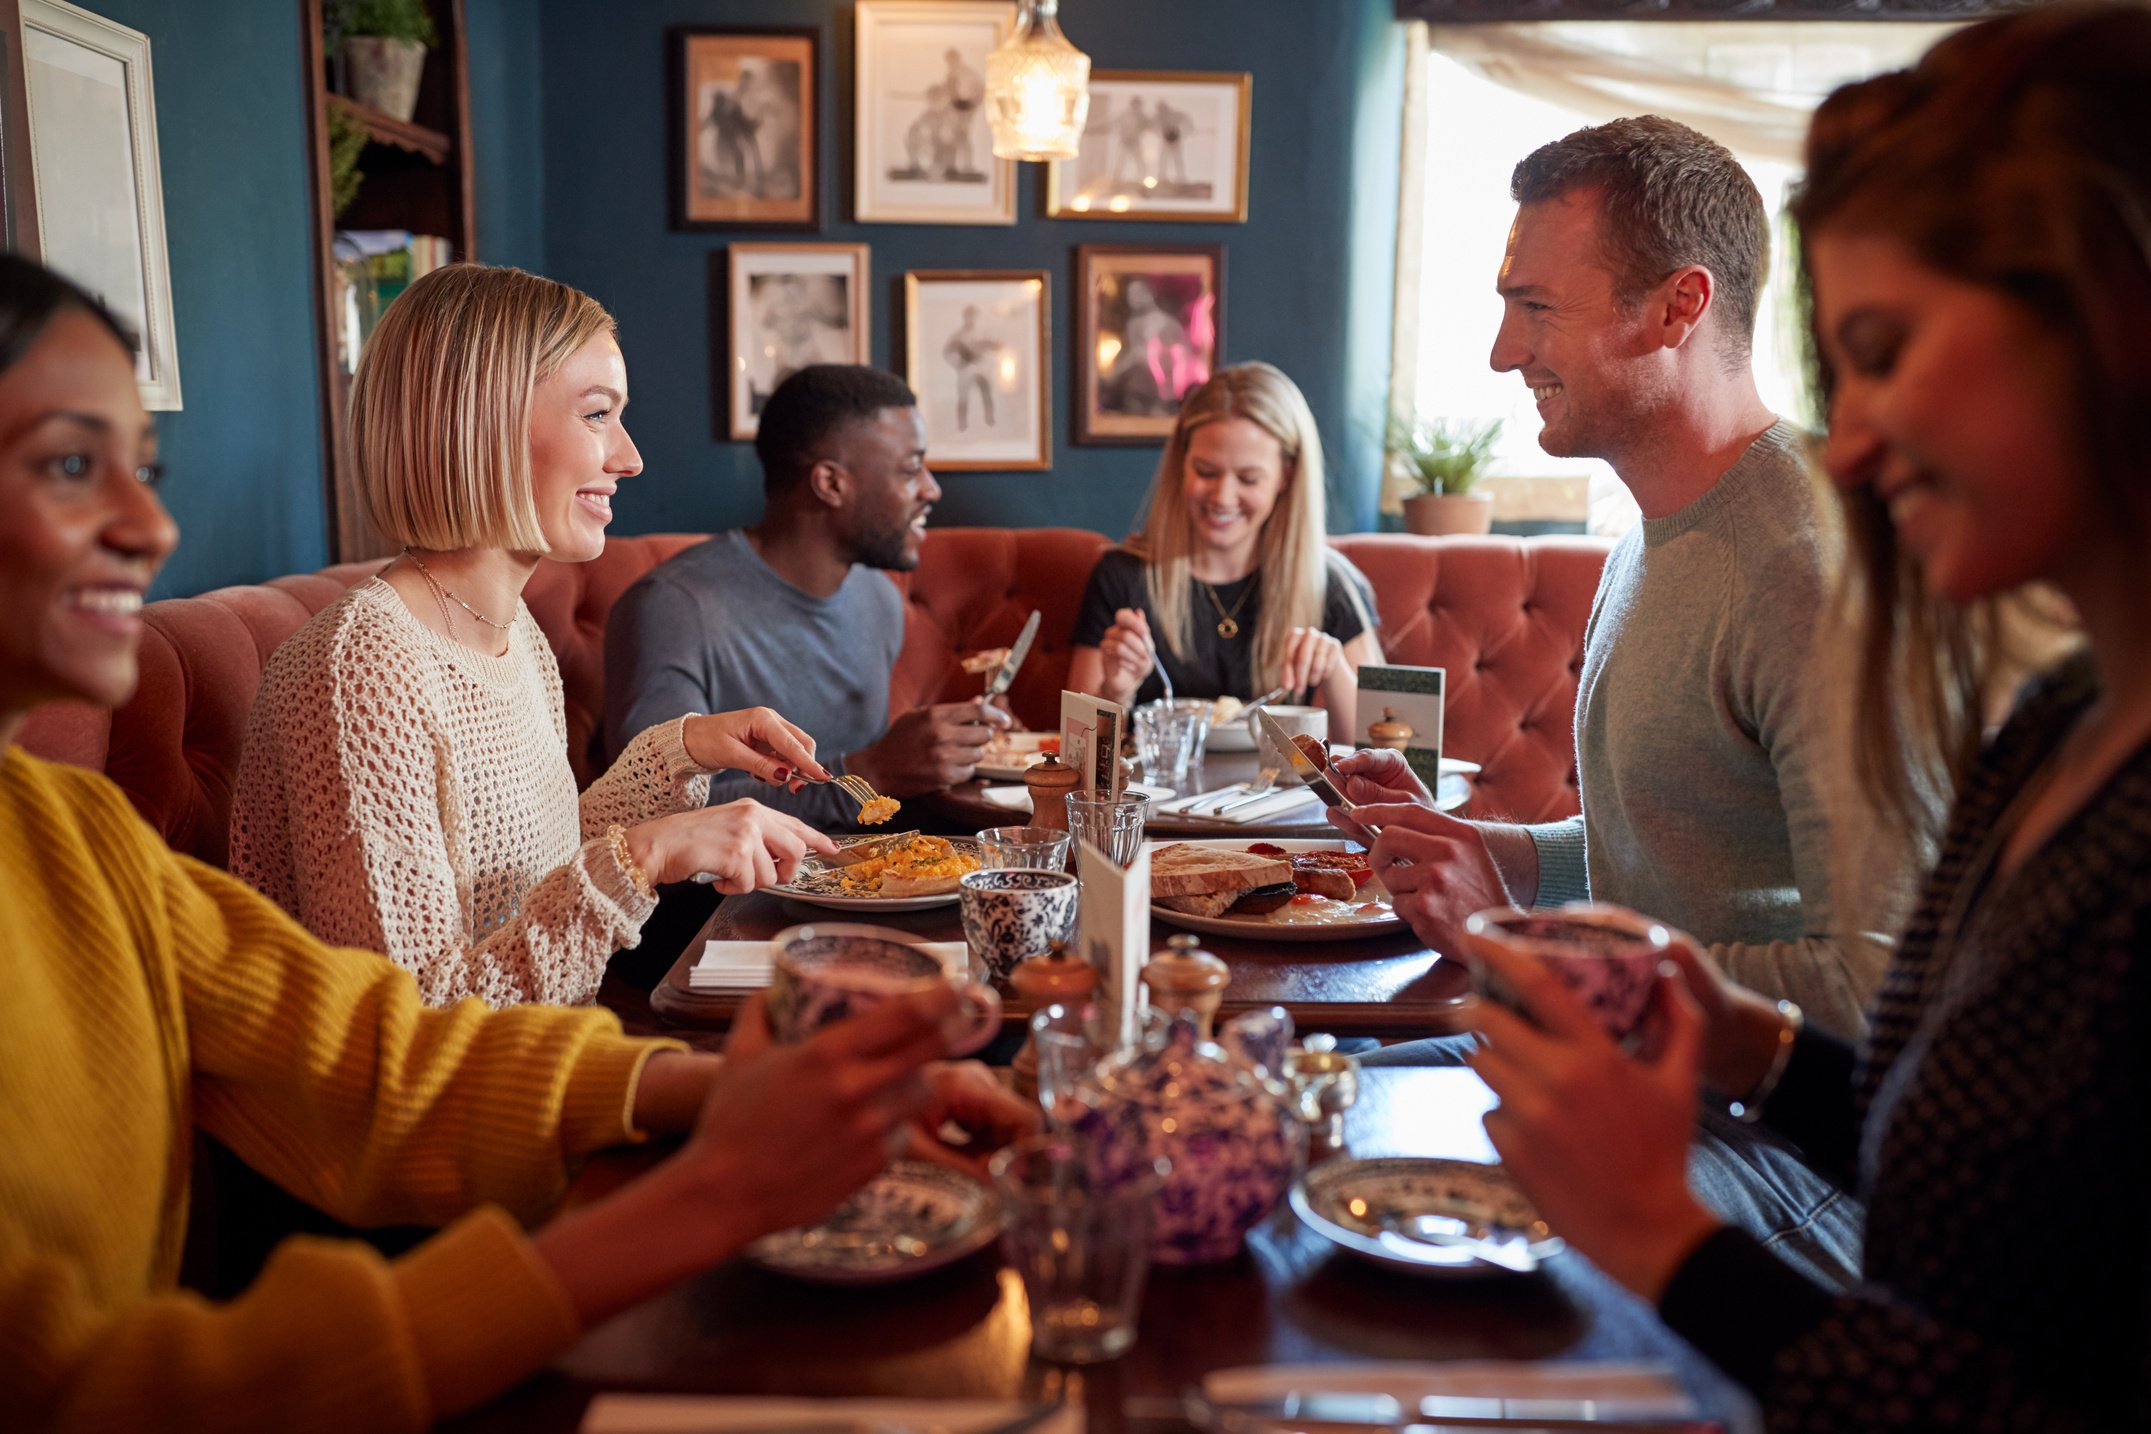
left=1508, top=114, right=1770, bottom=357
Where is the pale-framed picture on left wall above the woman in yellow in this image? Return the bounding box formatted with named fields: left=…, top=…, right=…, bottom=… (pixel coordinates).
left=4, top=0, right=179, bottom=411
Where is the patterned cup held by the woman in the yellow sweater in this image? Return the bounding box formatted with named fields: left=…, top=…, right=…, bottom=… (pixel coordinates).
left=768, top=922, right=1000, bottom=1056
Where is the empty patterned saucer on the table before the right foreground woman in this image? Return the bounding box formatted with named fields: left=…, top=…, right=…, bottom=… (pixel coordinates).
left=1293, top=1157, right=1564, bottom=1279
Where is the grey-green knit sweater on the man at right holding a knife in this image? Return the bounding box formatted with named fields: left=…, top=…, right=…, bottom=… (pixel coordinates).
left=1532, top=421, right=1917, bottom=1034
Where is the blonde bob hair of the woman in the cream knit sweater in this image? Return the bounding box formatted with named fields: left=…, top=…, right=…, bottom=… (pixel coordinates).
left=351, top=264, right=613, bottom=553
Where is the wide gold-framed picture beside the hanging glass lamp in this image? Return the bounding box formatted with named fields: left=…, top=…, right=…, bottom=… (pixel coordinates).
left=1045, top=69, right=1254, bottom=224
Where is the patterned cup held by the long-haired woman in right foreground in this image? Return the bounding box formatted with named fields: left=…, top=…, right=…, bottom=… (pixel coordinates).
left=1465, top=901, right=1673, bottom=1056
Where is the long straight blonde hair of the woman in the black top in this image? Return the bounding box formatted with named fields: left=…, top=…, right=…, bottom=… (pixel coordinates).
left=1127, top=363, right=1374, bottom=690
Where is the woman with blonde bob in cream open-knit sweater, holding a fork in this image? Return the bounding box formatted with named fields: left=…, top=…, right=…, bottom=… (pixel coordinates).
left=232, top=264, right=832, bottom=1006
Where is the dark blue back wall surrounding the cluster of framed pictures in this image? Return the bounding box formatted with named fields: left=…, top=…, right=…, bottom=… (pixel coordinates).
left=537, top=0, right=1402, bottom=546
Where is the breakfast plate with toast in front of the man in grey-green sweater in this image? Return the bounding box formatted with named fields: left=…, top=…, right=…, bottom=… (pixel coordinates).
left=1151, top=838, right=1405, bottom=942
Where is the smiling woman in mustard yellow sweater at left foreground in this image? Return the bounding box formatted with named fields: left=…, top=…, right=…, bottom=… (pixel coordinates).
left=0, top=256, right=1028, bottom=1430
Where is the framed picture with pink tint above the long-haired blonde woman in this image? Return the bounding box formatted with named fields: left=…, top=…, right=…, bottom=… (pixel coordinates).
left=1076, top=243, right=1224, bottom=443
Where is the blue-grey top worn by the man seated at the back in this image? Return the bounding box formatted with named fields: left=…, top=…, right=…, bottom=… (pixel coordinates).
left=604, top=529, right=903, bottom=828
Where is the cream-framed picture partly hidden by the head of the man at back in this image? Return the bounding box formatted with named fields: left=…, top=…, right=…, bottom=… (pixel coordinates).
left=725, top=243, right=869, bottom=439
